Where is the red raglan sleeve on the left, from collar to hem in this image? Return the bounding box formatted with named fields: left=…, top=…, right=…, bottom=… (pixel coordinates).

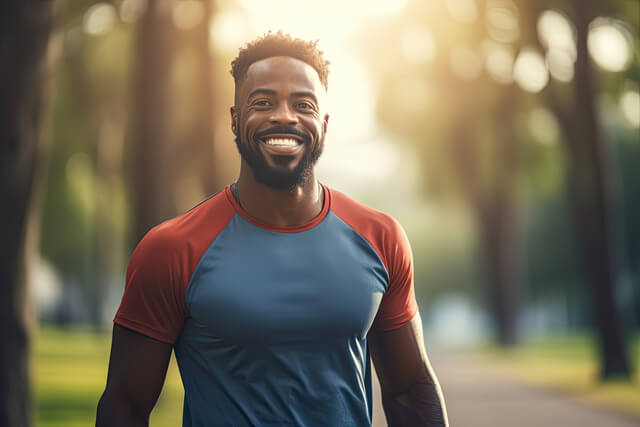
left=113, top=187, right=235, bottom=344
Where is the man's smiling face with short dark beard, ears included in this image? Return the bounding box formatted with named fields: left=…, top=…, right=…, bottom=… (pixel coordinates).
left=231, top=56, right=329, bottom=190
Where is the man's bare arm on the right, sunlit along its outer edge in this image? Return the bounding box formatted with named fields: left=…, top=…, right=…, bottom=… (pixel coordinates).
left=369, top=314, right=449, bottom=427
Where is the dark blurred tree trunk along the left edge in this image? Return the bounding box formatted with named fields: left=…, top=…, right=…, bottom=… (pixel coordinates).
left=0, top=0, right=53, bottom=427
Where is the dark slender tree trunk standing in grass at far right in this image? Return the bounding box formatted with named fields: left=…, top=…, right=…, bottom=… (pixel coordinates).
left=567, top=0, right=630, bottom=379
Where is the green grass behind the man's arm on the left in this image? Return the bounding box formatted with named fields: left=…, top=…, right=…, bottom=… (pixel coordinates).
left=32, top=328, right=183, bottom=427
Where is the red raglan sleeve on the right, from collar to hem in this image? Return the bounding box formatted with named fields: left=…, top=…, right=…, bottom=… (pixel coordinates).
left=330, top=190, right=418, bottom=331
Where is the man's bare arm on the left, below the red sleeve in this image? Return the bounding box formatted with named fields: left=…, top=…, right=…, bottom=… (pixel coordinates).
left=96, top=324, right=172, bottom=427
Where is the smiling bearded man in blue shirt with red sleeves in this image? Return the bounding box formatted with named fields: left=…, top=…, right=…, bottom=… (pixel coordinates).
left=97, top=33, right=447, bottom=427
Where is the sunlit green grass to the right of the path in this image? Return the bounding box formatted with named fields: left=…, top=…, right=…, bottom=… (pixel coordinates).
left=480, top=335, right=640, bottom=416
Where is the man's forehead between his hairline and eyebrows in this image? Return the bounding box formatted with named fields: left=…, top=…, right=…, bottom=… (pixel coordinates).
left=239, top=56, right=324, bottom=99
